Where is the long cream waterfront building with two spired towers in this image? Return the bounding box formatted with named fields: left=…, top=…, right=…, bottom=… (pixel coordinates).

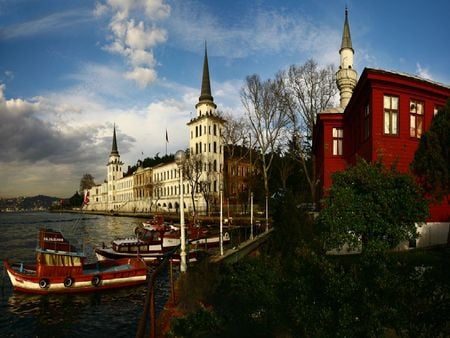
left=87, top=47, right=225, bottom=212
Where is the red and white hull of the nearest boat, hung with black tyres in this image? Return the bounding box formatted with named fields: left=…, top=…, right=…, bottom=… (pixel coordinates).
left=4, top=259, right=148, bottom=294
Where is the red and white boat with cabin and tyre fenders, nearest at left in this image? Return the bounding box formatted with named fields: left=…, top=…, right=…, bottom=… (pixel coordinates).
left=3, top=228, right=148, bottom=294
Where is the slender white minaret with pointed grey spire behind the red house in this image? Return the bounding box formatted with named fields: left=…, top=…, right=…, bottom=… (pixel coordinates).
left=336, top=8, right=357, bottom=108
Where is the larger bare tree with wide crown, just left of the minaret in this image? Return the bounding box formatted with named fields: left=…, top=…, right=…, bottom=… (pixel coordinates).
left=277, top=59, right=337, bottom=202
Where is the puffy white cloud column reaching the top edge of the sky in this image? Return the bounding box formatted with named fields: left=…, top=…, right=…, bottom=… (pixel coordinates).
left=94, top=0, right=171, bottom=88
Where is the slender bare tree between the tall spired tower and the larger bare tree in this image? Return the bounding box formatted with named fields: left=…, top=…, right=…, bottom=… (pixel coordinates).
left=241, top=75, right=287, bottom=226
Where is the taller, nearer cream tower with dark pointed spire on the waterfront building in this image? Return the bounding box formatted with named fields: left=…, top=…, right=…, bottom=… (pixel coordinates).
left=187, top=43, right=225, bottom=206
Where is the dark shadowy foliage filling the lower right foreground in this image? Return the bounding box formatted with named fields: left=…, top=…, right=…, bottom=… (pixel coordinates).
left=168, top=193, right=450, bottom=337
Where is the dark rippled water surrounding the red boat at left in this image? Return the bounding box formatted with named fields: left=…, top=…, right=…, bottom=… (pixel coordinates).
left=0, top=212, right=173, bottom=338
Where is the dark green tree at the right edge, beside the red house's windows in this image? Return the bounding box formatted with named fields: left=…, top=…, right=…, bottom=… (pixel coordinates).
left=411, top=99, right=450, bottom=201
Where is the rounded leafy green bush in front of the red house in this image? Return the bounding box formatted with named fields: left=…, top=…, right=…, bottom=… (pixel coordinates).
left=317, top=160, right=428, bottom=252
